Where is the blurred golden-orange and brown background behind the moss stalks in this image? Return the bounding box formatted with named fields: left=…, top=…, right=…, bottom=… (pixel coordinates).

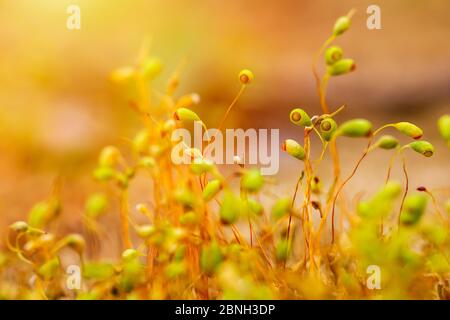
left=0, top=0, right=450, bottom=249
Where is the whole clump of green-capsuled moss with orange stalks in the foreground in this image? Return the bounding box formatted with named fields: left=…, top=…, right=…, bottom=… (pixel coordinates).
left=0, top=10, right=450, bottom=299
